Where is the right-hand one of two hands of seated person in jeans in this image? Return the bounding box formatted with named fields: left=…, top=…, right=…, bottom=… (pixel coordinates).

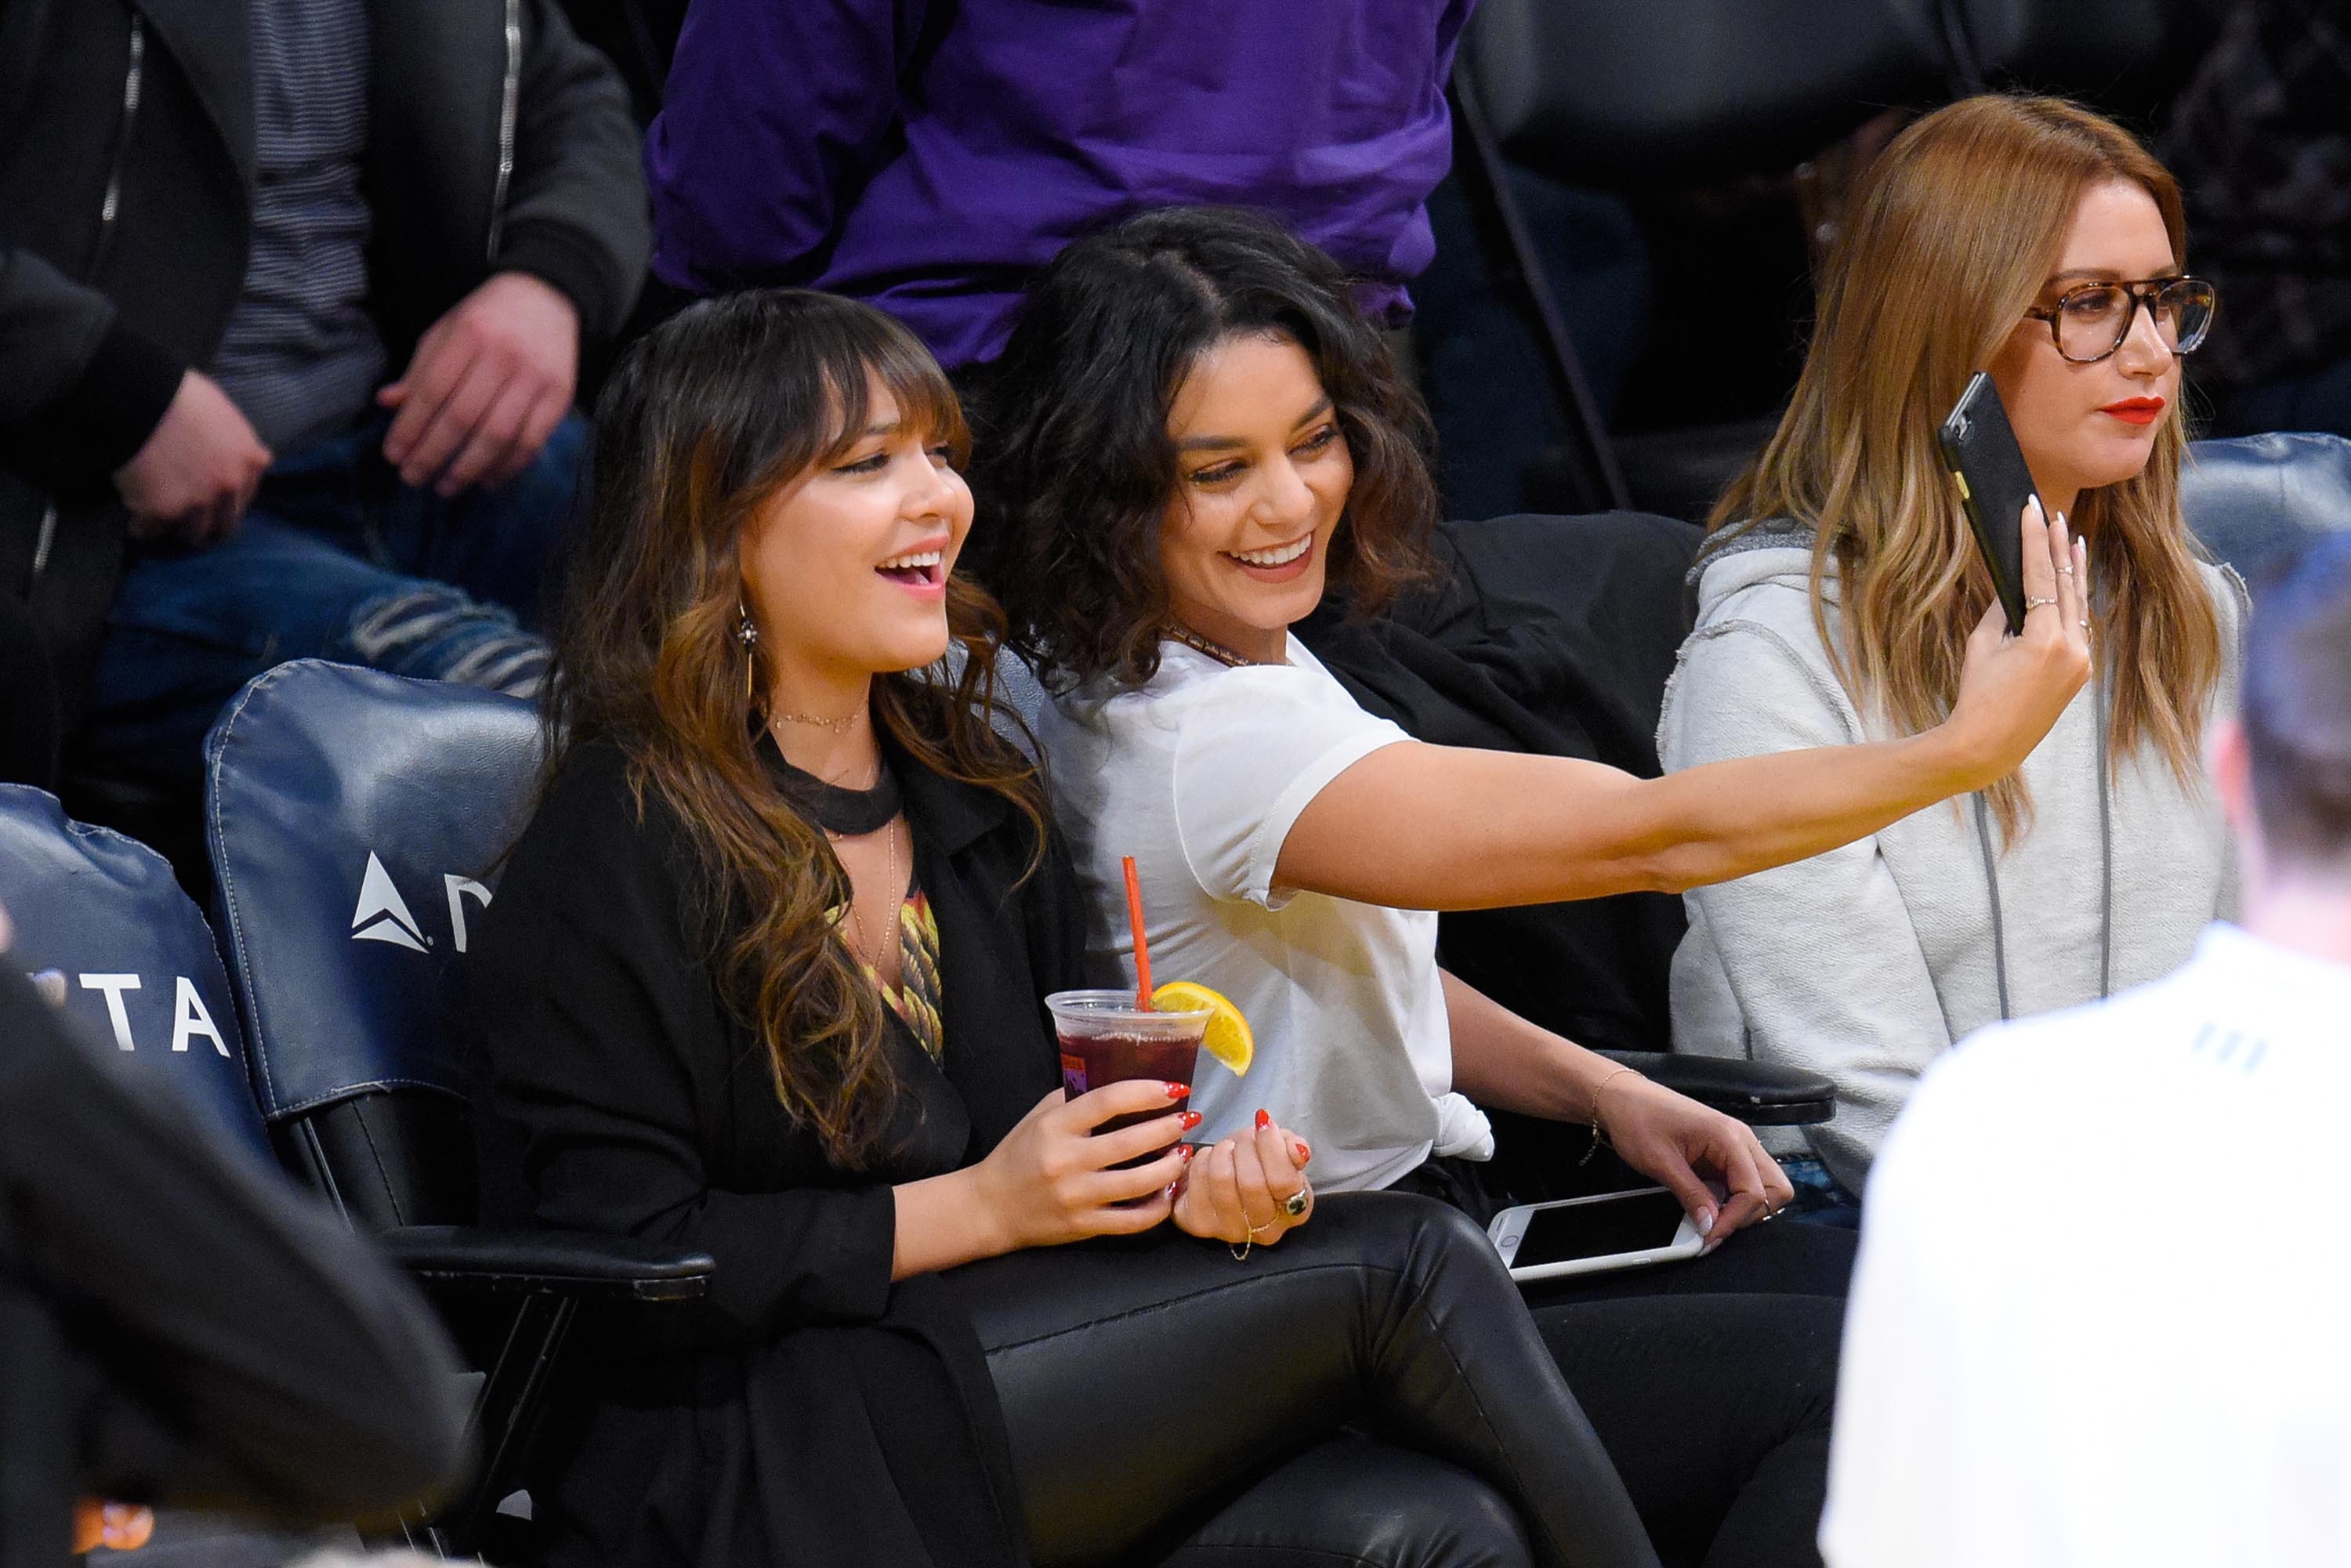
left=376, top=273, right=581, bottom=496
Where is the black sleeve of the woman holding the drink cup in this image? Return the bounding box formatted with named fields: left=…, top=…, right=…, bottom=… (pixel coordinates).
left=473, top=745, right=896, bottom=1345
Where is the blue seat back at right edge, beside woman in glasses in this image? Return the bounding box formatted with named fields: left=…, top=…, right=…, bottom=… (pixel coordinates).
left=2179, top=433, right=2351, bottom=583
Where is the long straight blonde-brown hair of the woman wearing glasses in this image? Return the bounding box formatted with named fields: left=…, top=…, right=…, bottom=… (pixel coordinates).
left=1709, top=94, right=2222, bottom=844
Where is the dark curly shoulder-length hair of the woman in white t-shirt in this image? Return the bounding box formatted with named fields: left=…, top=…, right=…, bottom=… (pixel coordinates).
left=971, top=207, right=1436, bottom=689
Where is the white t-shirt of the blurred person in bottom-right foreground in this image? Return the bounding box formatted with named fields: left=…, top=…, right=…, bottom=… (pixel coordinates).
left=1820, top=924, right=2351, bottom=1568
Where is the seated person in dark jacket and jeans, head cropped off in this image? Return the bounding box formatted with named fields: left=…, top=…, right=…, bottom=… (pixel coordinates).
left=0, top=0, right=651, bottom=799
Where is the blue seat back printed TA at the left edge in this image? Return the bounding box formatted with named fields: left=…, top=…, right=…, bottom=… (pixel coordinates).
left=0, top=785, right=270, bottom=1159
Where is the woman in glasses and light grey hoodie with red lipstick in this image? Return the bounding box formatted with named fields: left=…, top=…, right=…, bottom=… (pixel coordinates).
left=1660, top=96, right=2245, bottom=1213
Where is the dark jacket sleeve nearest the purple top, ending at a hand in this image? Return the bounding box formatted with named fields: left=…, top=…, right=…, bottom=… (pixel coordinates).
left=494, top=0, right=654, bottom=339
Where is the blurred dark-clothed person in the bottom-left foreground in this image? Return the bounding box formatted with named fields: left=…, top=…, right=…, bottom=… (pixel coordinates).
left=0, top=910, right=465, bottom=1568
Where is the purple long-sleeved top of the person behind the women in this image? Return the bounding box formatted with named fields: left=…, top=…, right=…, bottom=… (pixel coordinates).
left=644, top=0, right=1474, bottom=367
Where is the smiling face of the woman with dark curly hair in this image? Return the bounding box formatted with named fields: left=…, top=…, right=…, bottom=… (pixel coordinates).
left=1159, top=334, right=1354, bottom=661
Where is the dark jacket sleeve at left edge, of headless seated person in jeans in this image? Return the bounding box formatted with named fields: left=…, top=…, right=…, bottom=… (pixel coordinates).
left=0, top=247, right=188, bottom=480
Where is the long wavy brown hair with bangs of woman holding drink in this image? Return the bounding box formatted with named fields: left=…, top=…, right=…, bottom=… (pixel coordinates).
left=545, top=289, right=1044, bottom=1168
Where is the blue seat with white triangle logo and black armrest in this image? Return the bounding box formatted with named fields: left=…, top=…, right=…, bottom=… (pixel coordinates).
left=205, top=661, right=712, bottom=1552
